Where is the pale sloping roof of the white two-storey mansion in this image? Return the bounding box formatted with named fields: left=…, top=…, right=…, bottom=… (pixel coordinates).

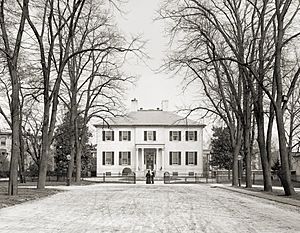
left=95, top=110, right=205, bottom=127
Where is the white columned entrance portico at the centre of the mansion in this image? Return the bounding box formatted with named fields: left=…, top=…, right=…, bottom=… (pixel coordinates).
left=135, top=144, right=165, bottom=177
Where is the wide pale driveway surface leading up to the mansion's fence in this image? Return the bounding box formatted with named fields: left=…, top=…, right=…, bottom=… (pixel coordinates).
left=0, top=183, right=300, bottom=233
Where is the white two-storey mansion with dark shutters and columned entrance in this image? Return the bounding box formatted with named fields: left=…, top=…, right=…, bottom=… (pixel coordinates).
left=95, top=100, right=204, bottom=177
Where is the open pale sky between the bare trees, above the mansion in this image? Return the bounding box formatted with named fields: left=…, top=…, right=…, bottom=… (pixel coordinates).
left=117, top=0, right=195, bottom=110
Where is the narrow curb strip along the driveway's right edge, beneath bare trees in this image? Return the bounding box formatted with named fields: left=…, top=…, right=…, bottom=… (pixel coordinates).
left=211, top=185, right=300, bottom=207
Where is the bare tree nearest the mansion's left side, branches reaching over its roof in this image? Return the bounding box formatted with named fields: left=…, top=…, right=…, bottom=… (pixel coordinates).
left=61, top=1, right=143, bottom=182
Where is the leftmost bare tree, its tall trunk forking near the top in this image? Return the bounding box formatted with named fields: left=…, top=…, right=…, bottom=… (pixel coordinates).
left=0, top=0, right=29, bottom=195
